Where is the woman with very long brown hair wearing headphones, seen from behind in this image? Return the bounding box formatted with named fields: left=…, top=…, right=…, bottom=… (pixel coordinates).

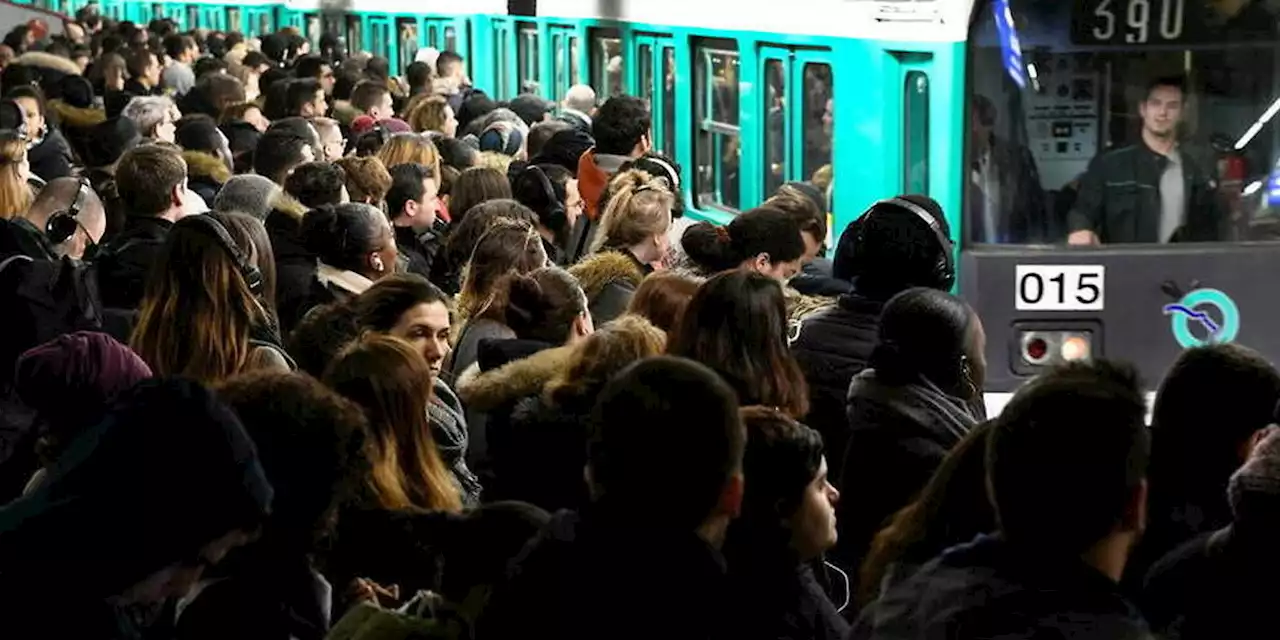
left=129, top=212, right=292, bottom=385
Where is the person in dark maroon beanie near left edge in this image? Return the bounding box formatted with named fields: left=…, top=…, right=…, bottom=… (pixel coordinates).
left=5, top=332, right=151, bottom=491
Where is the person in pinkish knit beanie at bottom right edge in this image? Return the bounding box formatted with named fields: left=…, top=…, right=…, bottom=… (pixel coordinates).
left=1138, top=425, right=1280, bottom=640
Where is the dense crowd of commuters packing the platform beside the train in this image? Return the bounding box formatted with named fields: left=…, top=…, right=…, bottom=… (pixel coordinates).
left=0, top=12, right=1280, bottom=640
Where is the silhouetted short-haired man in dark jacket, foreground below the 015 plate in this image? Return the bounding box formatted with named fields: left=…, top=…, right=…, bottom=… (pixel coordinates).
left=849, top=361, right=1151, bottom=640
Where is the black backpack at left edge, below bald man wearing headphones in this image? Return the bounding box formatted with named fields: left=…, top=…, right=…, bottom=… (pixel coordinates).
left=0, top=255, right=104, bottom=381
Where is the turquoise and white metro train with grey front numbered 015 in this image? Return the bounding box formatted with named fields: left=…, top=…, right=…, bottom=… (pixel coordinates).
left=20, top=0, right=1280, bottom=410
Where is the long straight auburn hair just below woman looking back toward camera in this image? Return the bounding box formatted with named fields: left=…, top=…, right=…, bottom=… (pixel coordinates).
left=325, top=334, right=462, bottom=512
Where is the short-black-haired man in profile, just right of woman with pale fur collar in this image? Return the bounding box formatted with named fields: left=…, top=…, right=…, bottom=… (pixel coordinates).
left=387, top=164, right=440, bottom=278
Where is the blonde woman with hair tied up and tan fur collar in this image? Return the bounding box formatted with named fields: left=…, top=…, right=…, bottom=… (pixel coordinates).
left=571, top=169, right=676, bottom=325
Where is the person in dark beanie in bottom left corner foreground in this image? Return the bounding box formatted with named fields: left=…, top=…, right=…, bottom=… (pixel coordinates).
left=0, top=379, right=274, bottom=637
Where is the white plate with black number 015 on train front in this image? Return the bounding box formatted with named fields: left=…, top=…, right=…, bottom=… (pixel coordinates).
left=1014, top=265, right=1106, bottom=311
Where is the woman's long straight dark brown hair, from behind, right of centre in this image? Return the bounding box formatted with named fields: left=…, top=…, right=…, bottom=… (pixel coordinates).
left=667, top=269, right=809, bottom=420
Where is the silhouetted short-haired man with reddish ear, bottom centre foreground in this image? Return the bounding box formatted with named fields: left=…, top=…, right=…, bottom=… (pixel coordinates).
left=477, top=356, right=746, bottom=640
